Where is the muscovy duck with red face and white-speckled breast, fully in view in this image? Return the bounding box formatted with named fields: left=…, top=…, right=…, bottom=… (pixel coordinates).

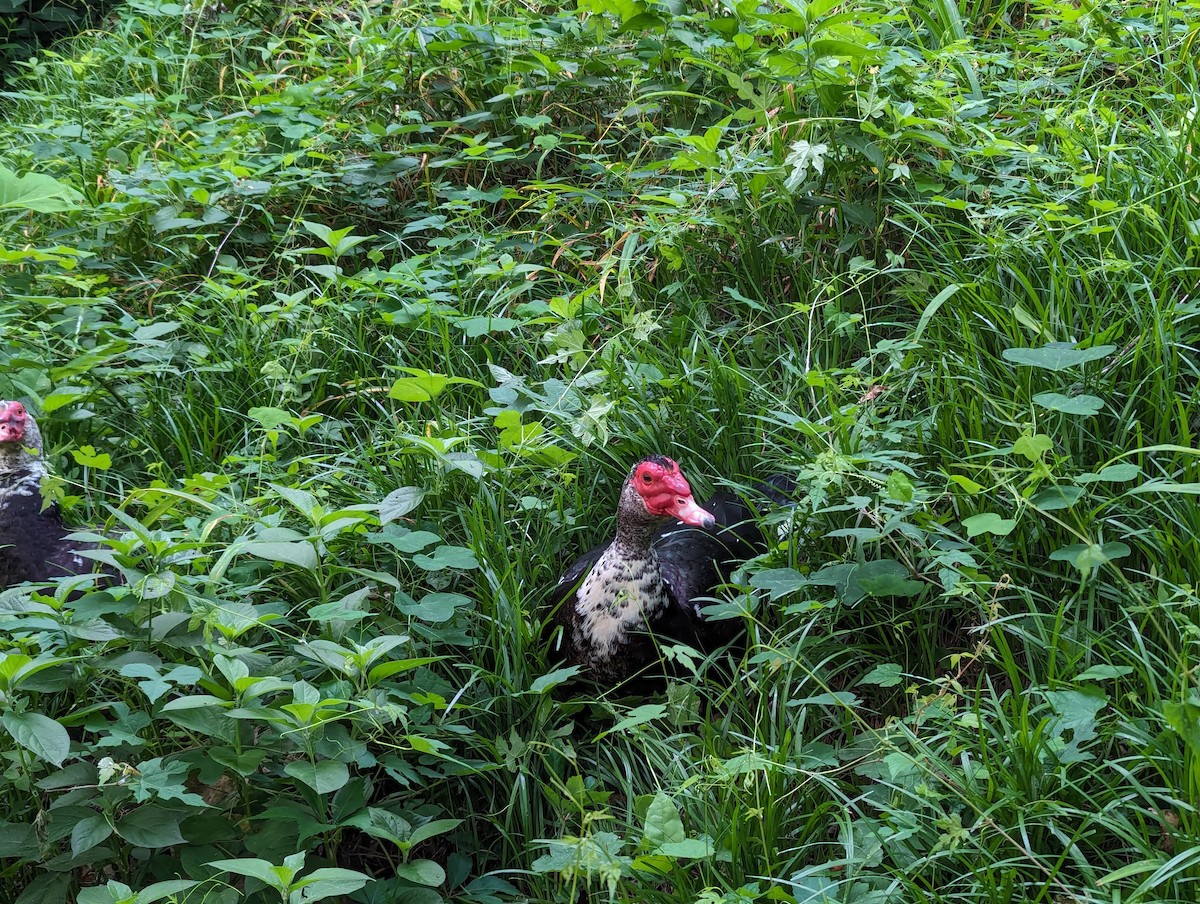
left=551, top=455, right=791, bottom=684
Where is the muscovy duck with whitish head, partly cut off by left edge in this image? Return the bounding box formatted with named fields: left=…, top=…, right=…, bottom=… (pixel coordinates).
left=0, top=401, right=106, bottom=589
